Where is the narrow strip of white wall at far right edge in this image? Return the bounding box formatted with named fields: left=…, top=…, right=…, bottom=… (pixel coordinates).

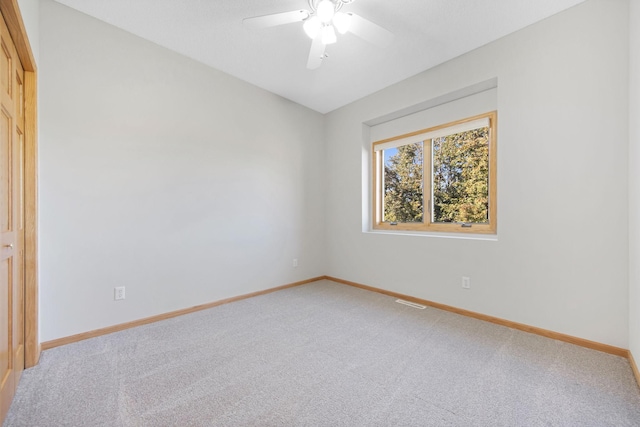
left=629, top=0, right=640, bottom=362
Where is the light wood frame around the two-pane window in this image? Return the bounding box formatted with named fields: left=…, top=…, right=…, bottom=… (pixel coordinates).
left=371, top=111, right=498, bottom=234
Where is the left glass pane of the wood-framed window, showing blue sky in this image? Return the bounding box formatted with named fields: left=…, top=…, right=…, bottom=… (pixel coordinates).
left=383, top=142, right=424, bottom=222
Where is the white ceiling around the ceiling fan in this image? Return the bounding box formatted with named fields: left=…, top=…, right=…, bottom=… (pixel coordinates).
left=56, top=0, right=584, bottom=113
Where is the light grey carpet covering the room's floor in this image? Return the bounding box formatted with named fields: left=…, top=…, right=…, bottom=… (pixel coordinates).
left=4, top=281, right=640, bottom=427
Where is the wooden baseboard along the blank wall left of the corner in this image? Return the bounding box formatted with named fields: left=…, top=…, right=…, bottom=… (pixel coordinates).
left=40, top=276, right=326, bottom=351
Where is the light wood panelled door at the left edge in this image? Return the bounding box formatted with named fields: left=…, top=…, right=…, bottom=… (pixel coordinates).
left=0, top=8, right=24, bottom=422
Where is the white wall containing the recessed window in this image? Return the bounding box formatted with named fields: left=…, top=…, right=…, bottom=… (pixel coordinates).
left=326, top=0, right=629, bottom=348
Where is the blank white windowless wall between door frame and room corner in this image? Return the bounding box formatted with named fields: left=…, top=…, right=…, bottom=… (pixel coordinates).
left=39, top=0, right=325, bottom=341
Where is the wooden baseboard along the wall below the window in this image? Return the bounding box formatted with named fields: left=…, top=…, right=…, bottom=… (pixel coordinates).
left=323, top=276, right=628, bottom=360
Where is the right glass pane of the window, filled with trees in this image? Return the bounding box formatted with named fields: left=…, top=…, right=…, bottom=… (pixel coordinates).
left=432, top=127, right=489, bottom=224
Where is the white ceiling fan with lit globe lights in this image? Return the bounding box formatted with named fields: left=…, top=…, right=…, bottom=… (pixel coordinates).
left=242, top=0, right=393, bottom=70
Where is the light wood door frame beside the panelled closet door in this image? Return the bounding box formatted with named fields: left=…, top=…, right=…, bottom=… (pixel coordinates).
left=0, top=0, right=40, bottom=368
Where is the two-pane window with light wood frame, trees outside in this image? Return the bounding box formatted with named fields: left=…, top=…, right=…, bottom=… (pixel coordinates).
left=373, top=112, right=497, bottom=234
